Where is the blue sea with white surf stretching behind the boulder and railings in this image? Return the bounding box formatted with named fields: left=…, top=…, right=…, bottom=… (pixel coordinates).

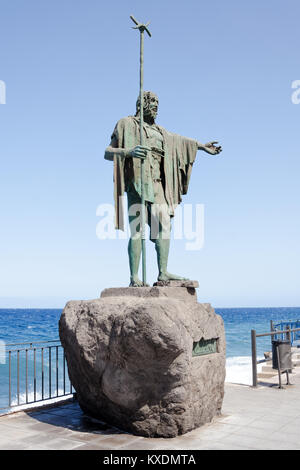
left=0, top=307, right=300, bottom=413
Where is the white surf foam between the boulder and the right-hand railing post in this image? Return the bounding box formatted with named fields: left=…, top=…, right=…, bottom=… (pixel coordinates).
left=225, top=356, right=262, bottom=385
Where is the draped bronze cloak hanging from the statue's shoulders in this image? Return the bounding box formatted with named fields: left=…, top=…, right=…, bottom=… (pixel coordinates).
left=106, top=116, right=198, bottom=230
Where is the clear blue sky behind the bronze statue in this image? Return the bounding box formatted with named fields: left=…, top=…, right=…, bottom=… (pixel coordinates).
left=0, top=0, right=300, bottom=308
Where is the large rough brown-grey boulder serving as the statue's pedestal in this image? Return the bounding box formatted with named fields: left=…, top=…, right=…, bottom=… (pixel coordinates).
left=59, top=286, right=225, bottom=437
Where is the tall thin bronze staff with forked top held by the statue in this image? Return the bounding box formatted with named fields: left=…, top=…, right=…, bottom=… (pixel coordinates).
left=130, top=15, right=151, bottom=286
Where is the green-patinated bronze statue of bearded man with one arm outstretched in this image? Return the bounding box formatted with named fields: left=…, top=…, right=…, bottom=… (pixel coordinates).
left=104, top=91, right=222, bottom=287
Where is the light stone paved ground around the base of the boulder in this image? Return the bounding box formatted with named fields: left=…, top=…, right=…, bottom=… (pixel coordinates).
left=0, top=373, right=300, bottom=450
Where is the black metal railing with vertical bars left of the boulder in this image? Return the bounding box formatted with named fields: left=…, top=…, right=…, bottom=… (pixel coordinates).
left=0, top=340, right=74, bottom=410
